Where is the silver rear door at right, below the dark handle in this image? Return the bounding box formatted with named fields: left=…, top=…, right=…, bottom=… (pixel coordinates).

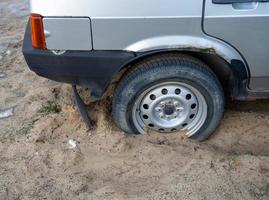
left=204, top=0, right=269, bottom=91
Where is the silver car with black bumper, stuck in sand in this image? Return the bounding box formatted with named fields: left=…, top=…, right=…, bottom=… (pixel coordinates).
left=23, top=0, right=269, bottom=141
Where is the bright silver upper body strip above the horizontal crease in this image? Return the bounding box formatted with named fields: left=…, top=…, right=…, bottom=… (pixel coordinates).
left=30, top=0, right=203, bottom=19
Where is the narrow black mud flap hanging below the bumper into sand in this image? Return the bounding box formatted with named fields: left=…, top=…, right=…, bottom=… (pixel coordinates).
left=72, top=85, right=94, bottom=129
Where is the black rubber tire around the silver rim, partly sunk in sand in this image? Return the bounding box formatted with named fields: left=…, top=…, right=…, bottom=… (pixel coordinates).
left=112, top=53, right=224, bottom=141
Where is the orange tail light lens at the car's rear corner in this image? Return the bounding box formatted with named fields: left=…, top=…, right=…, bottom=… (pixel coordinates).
left=30, top=14, right=46, bottom=49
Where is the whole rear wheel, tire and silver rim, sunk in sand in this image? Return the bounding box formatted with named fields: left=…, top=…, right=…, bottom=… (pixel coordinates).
left=112, top=53, right=225, bottom=141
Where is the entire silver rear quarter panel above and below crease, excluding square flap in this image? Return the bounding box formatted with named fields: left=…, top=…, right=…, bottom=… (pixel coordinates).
left=31, top=0, right=243, bottom=62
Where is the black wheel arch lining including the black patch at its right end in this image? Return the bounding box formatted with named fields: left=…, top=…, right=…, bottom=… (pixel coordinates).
left=109, top=48, right=248, bottom=99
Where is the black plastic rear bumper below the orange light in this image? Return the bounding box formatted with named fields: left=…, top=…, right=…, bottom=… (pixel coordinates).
left=22, top=25, right=135, bottom=99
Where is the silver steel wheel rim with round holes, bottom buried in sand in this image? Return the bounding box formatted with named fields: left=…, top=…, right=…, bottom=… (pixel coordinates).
left=132, top=82, right=207, bottom=137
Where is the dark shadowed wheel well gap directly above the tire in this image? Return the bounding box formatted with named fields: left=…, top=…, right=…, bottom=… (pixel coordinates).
left=109, top=51, right=236, bottom=97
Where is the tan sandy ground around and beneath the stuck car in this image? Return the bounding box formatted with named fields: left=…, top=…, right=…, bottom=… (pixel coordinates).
left=0, top=0, right=269, bottom=200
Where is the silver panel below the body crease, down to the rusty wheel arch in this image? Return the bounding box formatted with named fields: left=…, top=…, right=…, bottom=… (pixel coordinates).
left=92, top=17, right=243, bottom=65
